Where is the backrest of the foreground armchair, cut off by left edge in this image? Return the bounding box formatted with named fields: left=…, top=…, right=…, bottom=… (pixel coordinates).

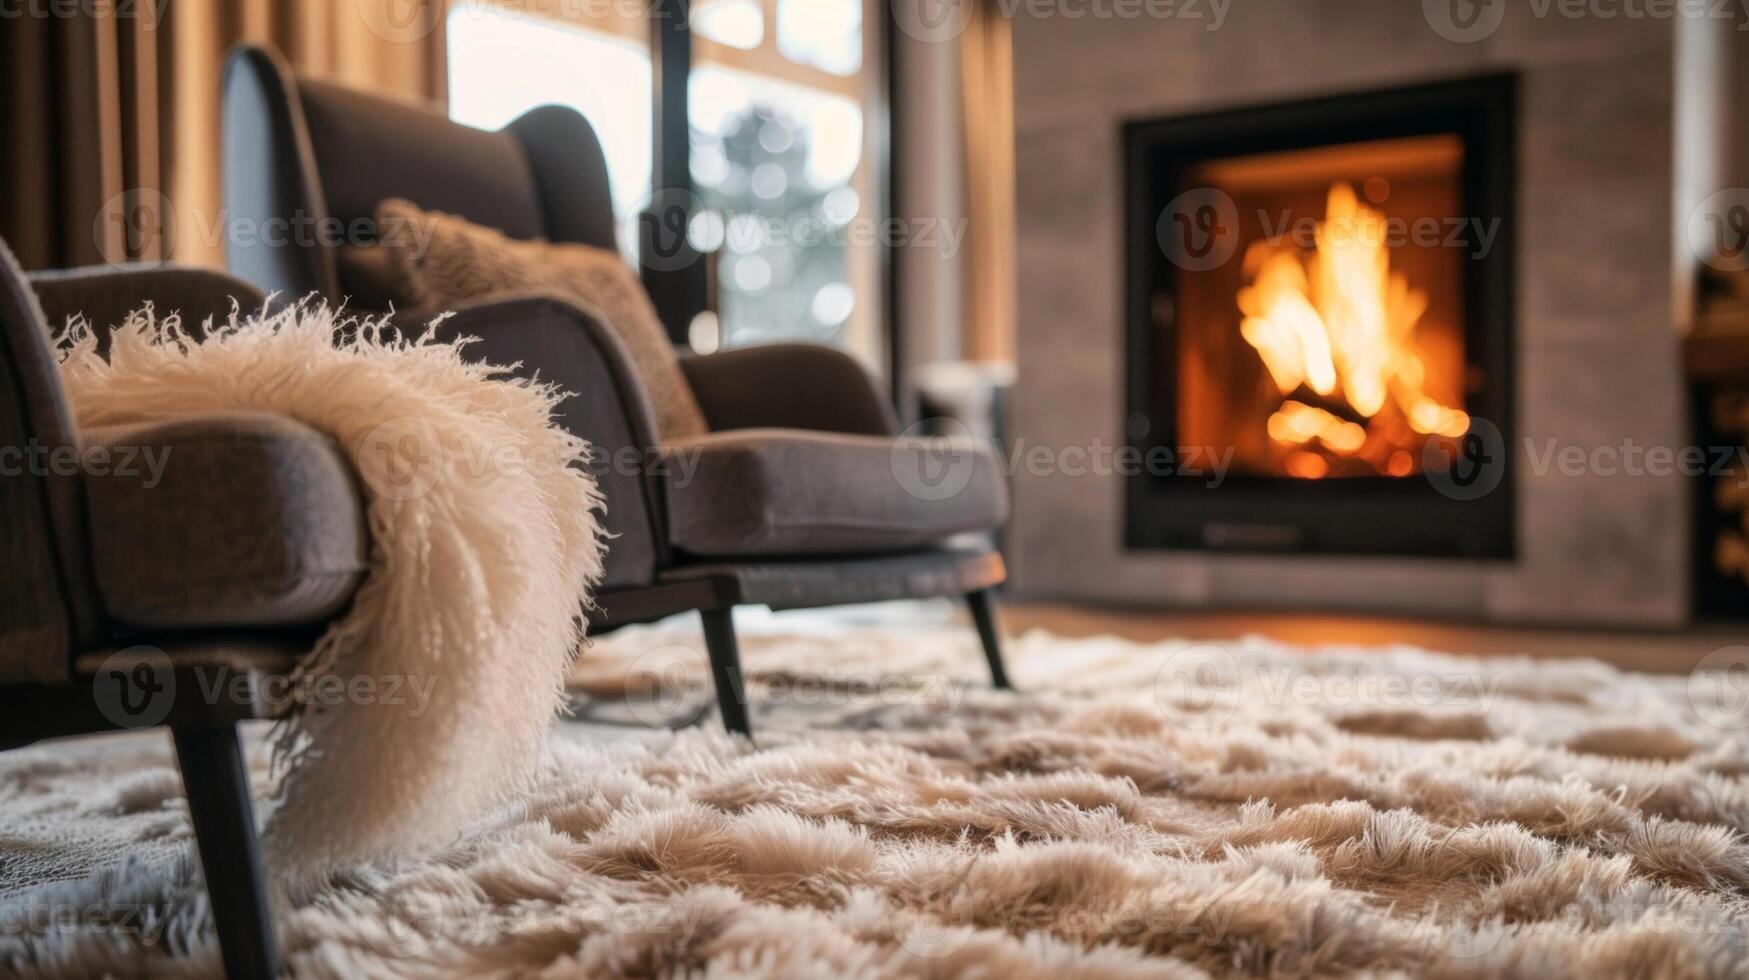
left=0, top=242, right=96, bottom=683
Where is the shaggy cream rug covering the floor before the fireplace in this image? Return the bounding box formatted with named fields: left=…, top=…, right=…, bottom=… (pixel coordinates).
left=0, top=616, right=1749, bottom=980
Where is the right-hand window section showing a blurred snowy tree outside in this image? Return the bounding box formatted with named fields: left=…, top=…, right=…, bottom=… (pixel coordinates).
left=687, top=0, right=881, bottom=361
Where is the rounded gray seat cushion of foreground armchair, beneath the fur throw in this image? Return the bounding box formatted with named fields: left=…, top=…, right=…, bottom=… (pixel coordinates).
left=80, top=413, right=369, bottom=634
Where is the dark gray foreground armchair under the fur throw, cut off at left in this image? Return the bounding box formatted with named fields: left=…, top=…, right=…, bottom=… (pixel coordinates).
left=0, top=243, right=369, bottom=977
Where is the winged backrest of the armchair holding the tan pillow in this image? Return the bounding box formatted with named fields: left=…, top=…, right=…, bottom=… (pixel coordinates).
left=224, top=46, right=616, bottom=299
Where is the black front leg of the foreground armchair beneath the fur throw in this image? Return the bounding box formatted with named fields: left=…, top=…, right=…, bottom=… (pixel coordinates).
left=175, top=725, right=280, bottom=980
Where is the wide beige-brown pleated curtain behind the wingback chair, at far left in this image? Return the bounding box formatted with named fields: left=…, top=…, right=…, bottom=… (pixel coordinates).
left=0, top=0, right=444, bottom=268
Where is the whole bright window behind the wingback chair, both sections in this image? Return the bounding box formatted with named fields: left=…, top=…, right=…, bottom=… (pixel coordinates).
left=446, top=0, right=885, bottom=362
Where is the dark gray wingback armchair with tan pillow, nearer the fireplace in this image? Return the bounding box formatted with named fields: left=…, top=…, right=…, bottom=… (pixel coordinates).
left=224, top=47, right=1007, bottom=733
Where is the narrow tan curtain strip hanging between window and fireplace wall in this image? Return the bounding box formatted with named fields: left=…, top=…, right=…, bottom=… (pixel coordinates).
left=960, top=0, right=1014, bottom=361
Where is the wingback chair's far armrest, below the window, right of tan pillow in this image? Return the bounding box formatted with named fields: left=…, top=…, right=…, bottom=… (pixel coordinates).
left=680, top=343, right=899, bottom=436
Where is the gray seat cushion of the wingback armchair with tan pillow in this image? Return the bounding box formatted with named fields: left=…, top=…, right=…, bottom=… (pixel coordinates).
left=663, top=429, right=1007, bottom=558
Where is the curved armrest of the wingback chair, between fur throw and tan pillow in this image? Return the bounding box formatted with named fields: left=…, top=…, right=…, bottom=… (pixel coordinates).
left=412, top=294, right=668, bottom=588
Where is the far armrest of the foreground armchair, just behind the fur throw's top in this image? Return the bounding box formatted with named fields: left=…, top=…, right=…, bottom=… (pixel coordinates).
left=28, top=264, right=266, bottom=334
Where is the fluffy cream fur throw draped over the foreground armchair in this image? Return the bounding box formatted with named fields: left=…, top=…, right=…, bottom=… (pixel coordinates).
left=61, top=303, right=602, bottom=875
